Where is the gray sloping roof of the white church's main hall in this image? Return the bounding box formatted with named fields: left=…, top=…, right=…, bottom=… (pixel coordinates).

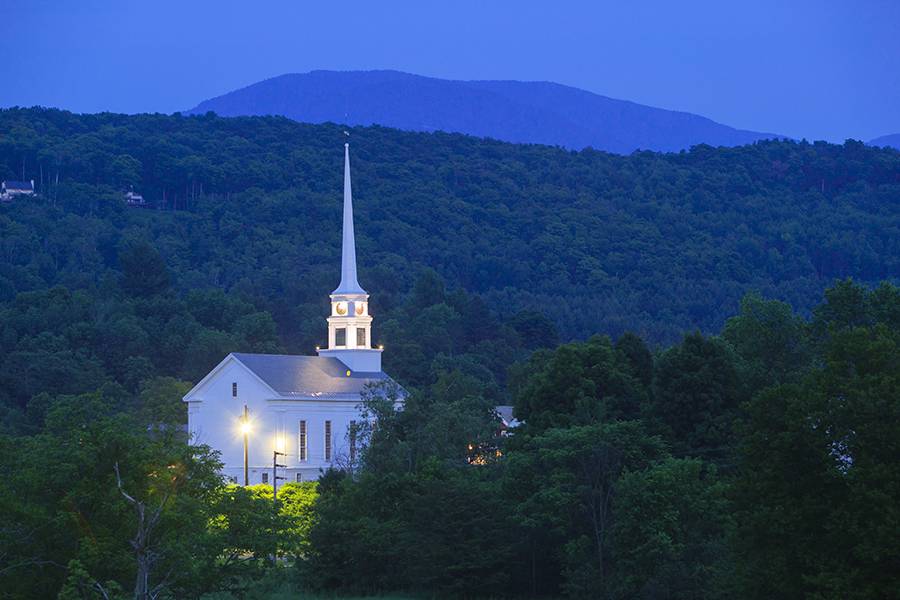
left=233, top=352, right=391, bottom=397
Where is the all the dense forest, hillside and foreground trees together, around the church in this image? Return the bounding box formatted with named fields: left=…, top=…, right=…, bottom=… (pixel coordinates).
left=0, top=109, right=900, bottom=600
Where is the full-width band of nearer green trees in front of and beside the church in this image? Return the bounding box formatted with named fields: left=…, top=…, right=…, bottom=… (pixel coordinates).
left=0, top=280, right=900, bottom=599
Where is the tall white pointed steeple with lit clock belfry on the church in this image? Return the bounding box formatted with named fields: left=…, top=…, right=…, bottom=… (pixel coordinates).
left=319, top=144, right=381, bottom=375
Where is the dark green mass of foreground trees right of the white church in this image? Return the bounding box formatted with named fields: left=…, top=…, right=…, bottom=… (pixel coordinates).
left=301, top=281, right=900, bottom=599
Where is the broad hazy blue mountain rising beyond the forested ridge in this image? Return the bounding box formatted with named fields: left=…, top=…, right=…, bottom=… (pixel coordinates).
left=188, top=71, right=783, bottom=154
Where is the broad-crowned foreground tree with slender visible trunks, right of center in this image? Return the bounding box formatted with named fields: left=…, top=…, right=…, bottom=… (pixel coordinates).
left=506, top=421, right=665, bottom=597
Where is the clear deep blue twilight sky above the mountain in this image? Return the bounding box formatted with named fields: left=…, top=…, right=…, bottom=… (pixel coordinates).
left=0, top=0, right=900, bottom=141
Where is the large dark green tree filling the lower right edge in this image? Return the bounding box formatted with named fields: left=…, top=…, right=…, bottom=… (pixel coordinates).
left=735, top=317, right=900, bottom=598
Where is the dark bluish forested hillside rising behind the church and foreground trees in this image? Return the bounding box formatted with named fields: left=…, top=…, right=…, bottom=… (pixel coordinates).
left=0, top=110, right=900, bottom=350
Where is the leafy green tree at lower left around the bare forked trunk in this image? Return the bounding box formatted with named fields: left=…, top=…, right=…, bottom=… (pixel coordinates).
left=0, top=393, right=221, bottom=598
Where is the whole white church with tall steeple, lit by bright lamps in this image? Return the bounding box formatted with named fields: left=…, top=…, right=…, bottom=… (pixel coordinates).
left=183, top=144, right=393, bottom=485
